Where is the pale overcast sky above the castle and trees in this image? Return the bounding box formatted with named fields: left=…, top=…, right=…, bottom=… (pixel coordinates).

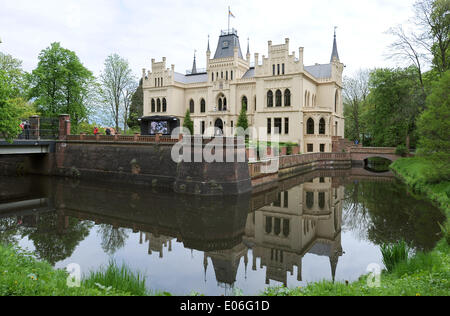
left=0, top=0, right=415, bottom=76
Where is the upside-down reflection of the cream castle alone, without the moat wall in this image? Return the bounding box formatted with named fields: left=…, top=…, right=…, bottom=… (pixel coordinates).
left=134, top=177, right=344, bottom=287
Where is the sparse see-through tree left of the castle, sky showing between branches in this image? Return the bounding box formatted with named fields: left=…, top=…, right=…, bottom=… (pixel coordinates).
left=100, top=54, right=136, bottom=131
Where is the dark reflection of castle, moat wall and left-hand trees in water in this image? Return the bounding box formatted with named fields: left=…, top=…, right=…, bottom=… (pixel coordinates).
left=0, top=173, right=344, bottom=287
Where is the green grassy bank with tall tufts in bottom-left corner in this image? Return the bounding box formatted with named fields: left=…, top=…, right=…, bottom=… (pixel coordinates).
left=0, top=245, right=170, bottom=296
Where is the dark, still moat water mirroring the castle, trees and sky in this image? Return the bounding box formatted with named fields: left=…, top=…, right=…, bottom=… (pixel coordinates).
left=0, top=170, right=444, bottom=295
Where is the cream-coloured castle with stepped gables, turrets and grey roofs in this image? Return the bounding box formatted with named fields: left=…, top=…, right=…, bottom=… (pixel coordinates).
left=142, top=29, right=344, bottom=153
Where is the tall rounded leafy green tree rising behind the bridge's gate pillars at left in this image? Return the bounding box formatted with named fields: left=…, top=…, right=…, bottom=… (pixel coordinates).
left=30, top=43, right=93, bottom=127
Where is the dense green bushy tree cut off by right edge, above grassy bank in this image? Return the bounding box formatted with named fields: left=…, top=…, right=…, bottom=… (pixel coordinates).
left=417, top=70, right=450, bottom=160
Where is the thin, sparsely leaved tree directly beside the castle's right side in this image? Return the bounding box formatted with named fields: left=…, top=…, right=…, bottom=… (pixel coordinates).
left=344, top=70, right=370, bottom=142
